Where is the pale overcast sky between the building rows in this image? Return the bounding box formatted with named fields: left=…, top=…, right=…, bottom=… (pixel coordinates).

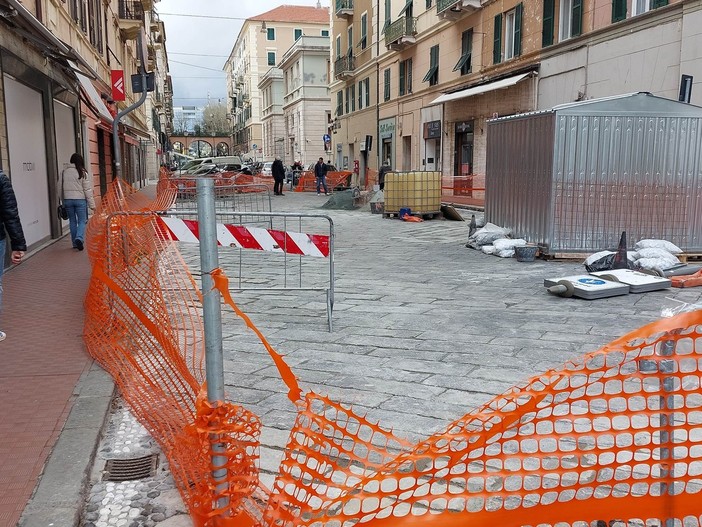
left=156, top=0, right=329, bottom=106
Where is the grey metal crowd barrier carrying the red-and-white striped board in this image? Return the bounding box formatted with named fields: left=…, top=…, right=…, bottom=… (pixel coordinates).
left=164, top=209, right=335, bottom=331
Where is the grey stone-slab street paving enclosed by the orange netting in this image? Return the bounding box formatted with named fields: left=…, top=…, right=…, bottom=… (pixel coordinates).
left=84, top=193, right=701, bottom=527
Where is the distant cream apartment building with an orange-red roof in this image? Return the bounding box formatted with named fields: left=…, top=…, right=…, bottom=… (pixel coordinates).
left=224, top=3, right=329, bottom=159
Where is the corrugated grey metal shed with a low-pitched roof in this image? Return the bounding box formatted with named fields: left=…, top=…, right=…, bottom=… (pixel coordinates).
left=485, top=93, right=702, bottom=255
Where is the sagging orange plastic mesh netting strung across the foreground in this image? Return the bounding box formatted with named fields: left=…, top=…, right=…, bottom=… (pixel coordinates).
left=85, top=178, right=702, bottom=527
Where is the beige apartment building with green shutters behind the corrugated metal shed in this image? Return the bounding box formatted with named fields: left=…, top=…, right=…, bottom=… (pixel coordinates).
left=331, top=0, right=702, bottom=184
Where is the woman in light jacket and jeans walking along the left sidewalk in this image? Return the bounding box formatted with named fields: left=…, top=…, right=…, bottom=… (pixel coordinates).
left=61, top=154, right=95, bottom=251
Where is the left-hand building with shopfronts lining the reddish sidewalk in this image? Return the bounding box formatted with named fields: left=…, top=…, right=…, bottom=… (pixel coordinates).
left=0, top=0, right=170, bottom=253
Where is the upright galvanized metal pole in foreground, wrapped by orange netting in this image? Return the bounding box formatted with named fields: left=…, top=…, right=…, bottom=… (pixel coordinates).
left=196, top=178, right=229, bottom=508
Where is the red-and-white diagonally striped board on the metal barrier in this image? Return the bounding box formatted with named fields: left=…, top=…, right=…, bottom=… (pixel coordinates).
left=157, top=216, right=329, bottom=258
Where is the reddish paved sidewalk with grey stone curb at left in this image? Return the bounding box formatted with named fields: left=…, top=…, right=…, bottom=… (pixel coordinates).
left=0, top=237, right=114, bottom=527
